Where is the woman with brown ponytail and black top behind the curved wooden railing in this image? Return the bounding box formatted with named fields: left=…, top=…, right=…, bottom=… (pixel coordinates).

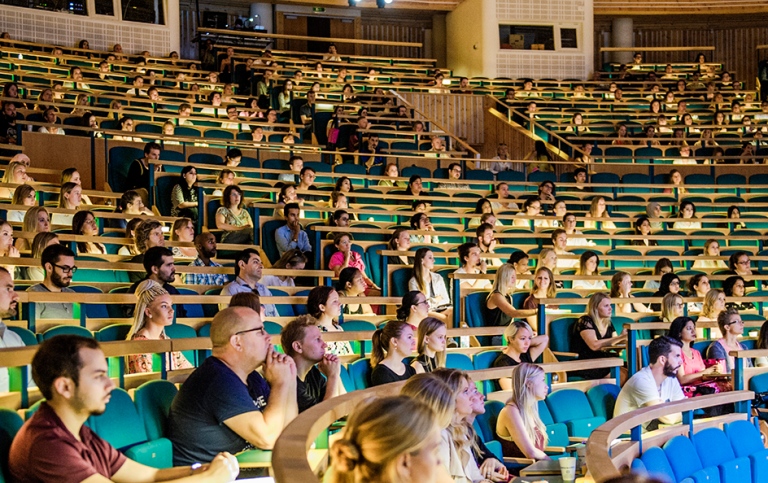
left=371, top=320, right=416, bottom=386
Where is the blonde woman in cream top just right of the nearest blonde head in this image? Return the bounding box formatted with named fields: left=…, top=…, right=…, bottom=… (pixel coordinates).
left=432, top=368, right=490, bottom=483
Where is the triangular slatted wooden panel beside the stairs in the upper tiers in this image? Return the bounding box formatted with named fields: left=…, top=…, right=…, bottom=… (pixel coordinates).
left=401, top=92, right=485, bottom=145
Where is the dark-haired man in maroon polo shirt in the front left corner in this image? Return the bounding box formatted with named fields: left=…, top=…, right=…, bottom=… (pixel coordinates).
left=8, top=335, right=239, bottom=483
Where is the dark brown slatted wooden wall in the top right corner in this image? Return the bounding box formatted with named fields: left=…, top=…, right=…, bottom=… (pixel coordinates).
left=595, top=14, right=768, bottom=89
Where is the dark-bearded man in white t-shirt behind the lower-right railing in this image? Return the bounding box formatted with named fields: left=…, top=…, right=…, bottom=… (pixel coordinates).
left=613, top=336, right=685, bottom=431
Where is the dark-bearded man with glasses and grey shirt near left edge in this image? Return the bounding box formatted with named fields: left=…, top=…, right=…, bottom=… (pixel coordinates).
left=27, top=245, right=77, bottom=319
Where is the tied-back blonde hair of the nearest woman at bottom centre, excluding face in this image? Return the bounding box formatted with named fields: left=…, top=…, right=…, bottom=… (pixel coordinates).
left=330, top=396, right=437, bottom=483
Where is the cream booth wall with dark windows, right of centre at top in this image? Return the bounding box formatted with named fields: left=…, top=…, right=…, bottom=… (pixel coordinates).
left=447, top=0, right=594, bottom=79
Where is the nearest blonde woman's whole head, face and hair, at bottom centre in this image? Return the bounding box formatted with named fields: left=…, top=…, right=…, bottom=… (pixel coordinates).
left=328, top=396, right=450, bottom=483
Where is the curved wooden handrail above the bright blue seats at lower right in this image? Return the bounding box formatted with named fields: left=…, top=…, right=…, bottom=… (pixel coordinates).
left=587, top=391, right=755, bottom=481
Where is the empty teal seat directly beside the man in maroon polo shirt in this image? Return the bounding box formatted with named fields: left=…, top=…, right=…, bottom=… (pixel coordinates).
left=88, top=388, right=173, bottom=468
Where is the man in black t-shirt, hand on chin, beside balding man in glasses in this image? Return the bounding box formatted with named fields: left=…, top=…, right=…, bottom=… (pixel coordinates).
left=280, top=315, right=345, bottom=412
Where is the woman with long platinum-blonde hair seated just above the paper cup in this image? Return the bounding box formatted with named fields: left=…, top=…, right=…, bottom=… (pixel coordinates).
left=496, top=363, right=551, bottom=460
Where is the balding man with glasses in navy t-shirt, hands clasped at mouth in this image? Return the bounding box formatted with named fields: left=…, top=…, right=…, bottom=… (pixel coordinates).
left=168, top=307, right=298, bottom=465
